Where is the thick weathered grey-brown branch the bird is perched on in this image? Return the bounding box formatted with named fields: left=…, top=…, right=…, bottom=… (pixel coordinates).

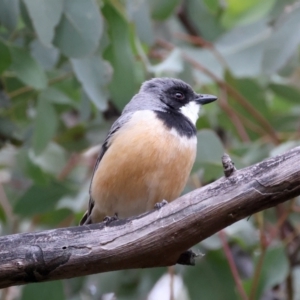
left=0, top=147, right=300, bottom=288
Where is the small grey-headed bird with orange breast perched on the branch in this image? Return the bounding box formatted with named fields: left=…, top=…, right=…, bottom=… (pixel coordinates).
left=80, top=78, right=217, bottom=225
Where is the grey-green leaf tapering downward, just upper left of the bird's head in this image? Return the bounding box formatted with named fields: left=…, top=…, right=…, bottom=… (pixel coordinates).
left=71, top=55, right=112, bottom=111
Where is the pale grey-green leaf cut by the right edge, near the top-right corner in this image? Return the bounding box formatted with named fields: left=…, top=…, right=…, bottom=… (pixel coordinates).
left=262, top=6, right=300, bottom=74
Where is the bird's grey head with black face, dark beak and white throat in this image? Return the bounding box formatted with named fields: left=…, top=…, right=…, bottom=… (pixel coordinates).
left=123, top=78, right=217, bottom=127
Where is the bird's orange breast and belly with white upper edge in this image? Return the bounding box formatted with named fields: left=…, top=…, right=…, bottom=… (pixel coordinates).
left=91, top=111, right=196, bottom=222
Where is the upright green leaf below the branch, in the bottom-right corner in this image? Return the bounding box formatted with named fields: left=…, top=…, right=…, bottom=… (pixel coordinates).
left=256, top=246, right=289, bottom=299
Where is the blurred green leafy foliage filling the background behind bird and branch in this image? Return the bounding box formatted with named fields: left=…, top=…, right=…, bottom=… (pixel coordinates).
left=0, top=0, right=300, bottom=300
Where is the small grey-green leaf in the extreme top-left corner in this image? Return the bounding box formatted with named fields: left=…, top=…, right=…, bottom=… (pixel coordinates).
left=0, top=0, right=20, bottom=31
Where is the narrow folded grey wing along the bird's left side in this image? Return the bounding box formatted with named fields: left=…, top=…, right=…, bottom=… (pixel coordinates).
left=79, top=113, right=132, bottom=225
